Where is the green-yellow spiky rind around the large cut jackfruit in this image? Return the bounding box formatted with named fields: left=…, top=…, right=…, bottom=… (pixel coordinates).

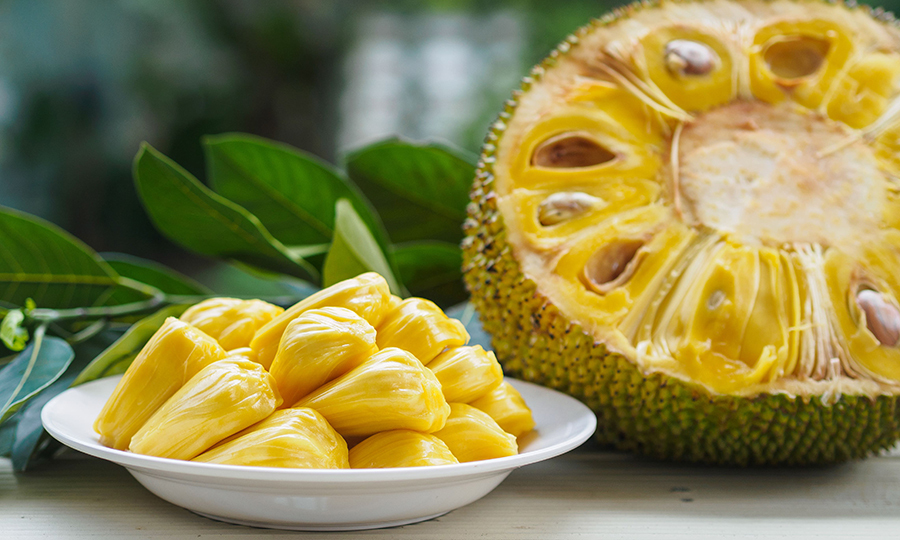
left=462, top=0, right=900, bottom=465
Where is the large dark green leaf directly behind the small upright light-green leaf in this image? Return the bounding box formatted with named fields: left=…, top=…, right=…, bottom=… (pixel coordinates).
left=204, top=133, right=388, bottom=253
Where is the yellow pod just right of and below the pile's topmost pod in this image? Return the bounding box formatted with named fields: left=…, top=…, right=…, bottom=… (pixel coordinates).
left=377, top=298, right=469, bottom=365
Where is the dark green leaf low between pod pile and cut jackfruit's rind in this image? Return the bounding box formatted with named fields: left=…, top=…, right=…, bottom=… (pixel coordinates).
left=393, top=242, right=469, bottom=306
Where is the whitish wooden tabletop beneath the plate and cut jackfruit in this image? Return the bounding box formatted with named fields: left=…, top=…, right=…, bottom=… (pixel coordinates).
left=0, top=443, right=900, bottom=540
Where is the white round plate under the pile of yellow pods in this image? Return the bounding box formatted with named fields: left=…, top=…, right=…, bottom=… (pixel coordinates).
left=41, top=376, right=597, bottom=530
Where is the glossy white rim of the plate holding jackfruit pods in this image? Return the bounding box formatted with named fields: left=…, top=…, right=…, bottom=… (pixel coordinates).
left=41, top=375, right=597, bottom=485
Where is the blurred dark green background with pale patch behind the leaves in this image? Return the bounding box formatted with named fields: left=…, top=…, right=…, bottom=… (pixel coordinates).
left=0, top=0, right=900, bottom=294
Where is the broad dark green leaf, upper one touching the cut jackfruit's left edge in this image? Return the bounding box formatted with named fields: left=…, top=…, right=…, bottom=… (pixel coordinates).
left=347, top=139, right=475, bottom=244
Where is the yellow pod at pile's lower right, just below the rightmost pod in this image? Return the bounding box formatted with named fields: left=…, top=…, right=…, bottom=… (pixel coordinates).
left=434, top=403, right=519, bottom=463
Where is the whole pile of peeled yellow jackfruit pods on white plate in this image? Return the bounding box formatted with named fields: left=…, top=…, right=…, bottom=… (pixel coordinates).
left=94, top=273, right=534, bottom=469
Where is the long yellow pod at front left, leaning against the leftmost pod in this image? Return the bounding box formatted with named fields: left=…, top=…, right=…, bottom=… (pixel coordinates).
left=129, top=359, right=281, bottom=459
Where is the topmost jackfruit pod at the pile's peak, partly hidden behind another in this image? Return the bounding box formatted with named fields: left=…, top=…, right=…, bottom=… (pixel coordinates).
left=250, top=272, right=391, bottom=369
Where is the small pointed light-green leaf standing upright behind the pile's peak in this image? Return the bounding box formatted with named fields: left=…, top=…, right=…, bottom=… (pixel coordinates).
left=322, top=199, right=405, bottom=294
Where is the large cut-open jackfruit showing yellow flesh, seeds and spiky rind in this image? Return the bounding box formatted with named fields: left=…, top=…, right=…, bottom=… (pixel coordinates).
left=464, top=0, right=900, bottom=465
